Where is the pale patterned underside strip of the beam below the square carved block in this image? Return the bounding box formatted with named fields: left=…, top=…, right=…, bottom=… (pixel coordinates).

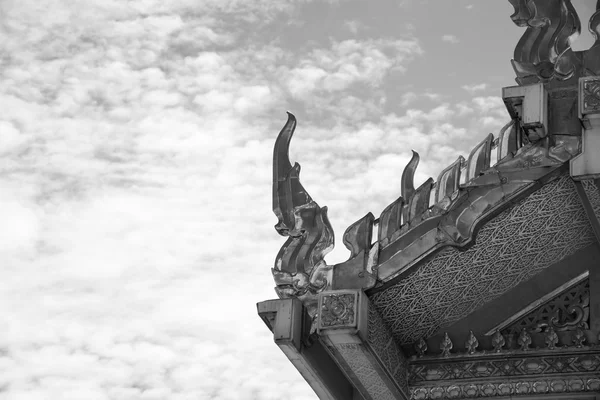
left=336, top=343, right=396, bottom=400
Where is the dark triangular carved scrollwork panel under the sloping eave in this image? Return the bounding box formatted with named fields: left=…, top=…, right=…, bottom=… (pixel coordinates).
left=502, top=279, right=590, bottom=335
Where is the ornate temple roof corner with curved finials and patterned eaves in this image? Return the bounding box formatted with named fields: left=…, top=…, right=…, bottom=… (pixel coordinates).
left=257, top=0, right=600, bottom=400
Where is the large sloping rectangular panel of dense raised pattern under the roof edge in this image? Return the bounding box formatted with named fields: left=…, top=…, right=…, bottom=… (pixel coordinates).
left=371, top=175, right=595, bottom=345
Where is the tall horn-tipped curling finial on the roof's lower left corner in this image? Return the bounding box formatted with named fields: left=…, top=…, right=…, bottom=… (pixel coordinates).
left=272, top=113, right=334, bottom=315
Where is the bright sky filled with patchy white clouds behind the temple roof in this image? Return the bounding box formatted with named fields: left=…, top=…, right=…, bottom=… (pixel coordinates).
left=0, top=0, right=592, bottom=400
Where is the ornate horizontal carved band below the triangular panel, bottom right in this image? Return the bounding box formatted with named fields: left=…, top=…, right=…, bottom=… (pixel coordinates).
left=409, top=346, right=600, bottom=399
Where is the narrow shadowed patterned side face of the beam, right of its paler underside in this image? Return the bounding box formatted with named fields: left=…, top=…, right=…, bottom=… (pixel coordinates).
left=367, top=305, right=409, bottom=396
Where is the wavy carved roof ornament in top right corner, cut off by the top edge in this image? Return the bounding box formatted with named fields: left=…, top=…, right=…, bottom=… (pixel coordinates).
left=509, top=0, right=581, bottom=85
